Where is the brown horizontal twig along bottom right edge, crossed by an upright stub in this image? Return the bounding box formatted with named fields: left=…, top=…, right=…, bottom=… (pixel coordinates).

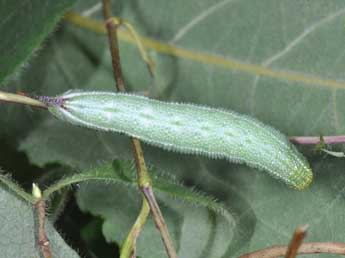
left=240, top=242, right=345, bottom=258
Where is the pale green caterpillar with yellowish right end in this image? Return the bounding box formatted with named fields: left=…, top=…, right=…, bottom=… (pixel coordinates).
left=39, top=91, right=313, bottom=190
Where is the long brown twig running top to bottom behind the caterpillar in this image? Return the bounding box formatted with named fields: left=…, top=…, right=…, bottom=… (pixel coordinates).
left=103, top=0, right=177, bottom=258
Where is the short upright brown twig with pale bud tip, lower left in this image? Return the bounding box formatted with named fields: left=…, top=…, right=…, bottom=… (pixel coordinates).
left=32, top=184, right=53, bottom=258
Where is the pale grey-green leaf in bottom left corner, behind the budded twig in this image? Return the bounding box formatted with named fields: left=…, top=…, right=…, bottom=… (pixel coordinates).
left=0, top=184, right=79, bottom=258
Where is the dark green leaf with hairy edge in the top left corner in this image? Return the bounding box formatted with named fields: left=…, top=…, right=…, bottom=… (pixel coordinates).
left=0, top=0, right=75, bottom=84
